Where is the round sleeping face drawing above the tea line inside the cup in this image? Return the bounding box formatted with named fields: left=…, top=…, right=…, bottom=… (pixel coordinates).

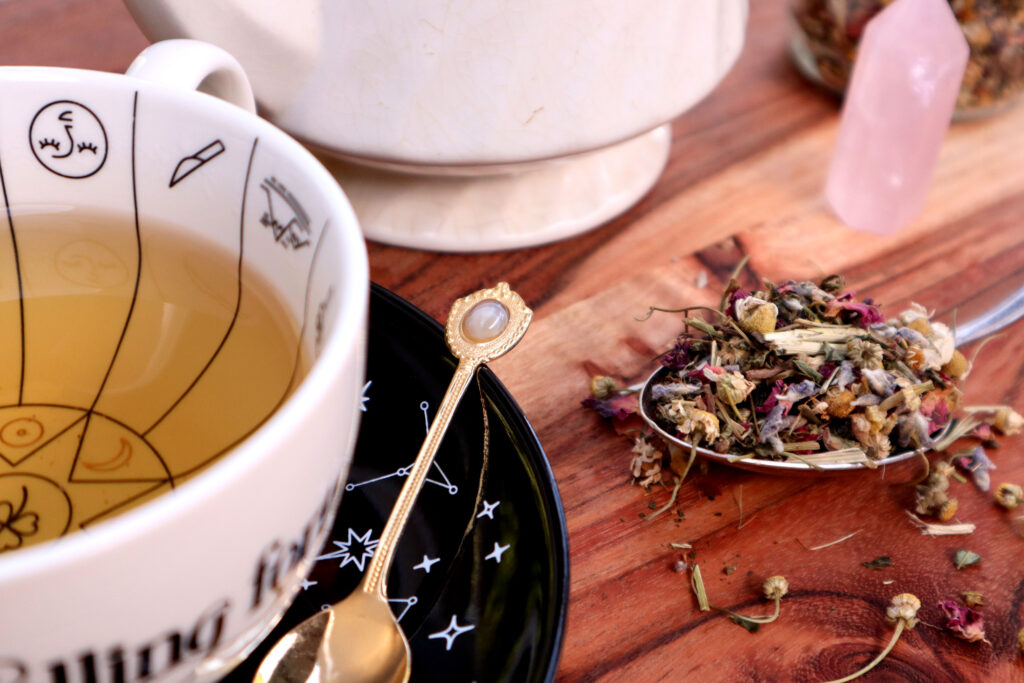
left=29, top=99, right=106, bottom=178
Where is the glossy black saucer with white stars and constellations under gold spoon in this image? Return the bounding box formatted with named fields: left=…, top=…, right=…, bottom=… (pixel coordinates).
left=225, top=285, right=568, bottom=682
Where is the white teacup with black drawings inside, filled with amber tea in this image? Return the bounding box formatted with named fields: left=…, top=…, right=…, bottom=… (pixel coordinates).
left=0, top=43, right=369, bottom=683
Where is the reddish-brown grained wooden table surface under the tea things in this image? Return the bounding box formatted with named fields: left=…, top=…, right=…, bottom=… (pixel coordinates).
left=0, top=0, right=1024, bottom=681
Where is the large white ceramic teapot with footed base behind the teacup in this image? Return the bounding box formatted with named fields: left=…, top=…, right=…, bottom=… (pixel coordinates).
left=125, top=0, right=748, bottom=251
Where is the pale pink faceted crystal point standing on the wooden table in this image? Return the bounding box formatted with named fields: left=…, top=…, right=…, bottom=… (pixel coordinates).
left=825, top=0, right=969, bottom=234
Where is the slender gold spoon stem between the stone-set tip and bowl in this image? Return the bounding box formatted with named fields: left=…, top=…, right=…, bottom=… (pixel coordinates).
left=359, top=358, right=480, bottom=598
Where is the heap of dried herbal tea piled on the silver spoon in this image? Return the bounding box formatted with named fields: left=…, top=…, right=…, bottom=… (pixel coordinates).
left=643, top=275, right=969, bottom=466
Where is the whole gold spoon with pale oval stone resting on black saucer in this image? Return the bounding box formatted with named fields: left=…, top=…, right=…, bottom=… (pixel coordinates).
left=253, top=283, right=534, bottom=683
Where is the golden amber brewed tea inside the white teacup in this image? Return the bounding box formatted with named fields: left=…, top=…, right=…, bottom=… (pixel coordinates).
left=0, top=207, right=309, bottom=553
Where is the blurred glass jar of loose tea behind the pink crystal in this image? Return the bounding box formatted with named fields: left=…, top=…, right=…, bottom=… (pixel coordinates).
left=790, top=0, right=1024, bottom=118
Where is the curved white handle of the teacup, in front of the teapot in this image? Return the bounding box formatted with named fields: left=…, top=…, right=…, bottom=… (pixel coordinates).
left=125, top=39, right=256, bottom=114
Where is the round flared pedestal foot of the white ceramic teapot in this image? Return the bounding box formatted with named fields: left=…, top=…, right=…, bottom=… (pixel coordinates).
left=321, top=124, right=672, bottom=252
